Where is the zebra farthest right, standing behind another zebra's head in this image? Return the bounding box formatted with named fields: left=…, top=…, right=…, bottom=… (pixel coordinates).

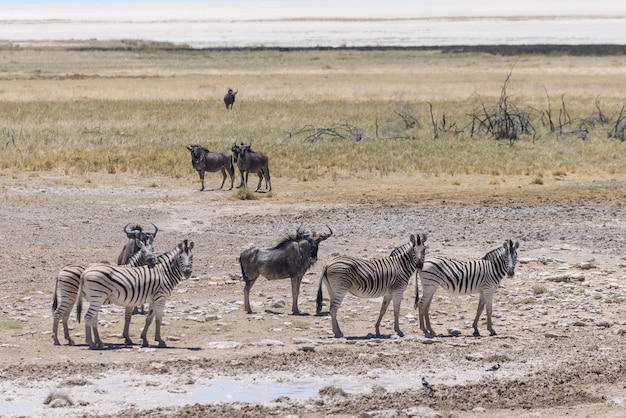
left=415, top=240, right=519, bottom=338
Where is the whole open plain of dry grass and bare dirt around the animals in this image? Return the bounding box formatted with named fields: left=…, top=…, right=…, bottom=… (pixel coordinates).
left=0, top=41, right=626, bottom=417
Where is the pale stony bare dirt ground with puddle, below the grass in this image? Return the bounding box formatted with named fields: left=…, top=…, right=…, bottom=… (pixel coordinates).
left=0, top=171, right=626, bottom=417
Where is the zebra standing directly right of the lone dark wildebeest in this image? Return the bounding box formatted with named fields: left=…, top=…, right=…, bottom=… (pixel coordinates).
left=317, top=234, right=426, bottom=338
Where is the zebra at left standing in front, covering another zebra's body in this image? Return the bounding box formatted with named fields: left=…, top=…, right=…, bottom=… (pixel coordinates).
left=76, top=240, right=193, bottom=349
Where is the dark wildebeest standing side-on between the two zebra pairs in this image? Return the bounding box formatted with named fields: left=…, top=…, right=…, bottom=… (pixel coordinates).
left=239, top=227, right=333, bottom=315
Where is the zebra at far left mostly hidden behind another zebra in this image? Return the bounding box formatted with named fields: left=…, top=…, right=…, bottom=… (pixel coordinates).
left=52, top=238, right=157, bottom=345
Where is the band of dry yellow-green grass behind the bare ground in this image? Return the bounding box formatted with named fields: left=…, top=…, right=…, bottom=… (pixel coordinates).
left=0, top=44, right=626, bottom=204
